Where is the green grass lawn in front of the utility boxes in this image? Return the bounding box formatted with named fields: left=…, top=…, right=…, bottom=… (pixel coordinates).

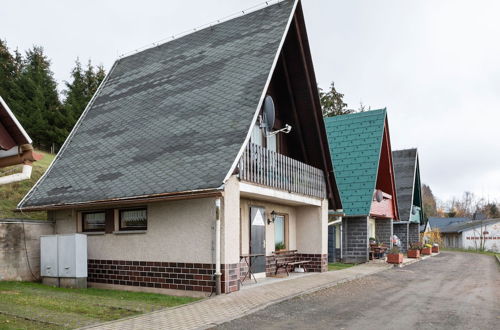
left=0, top=282, right=198, bottom=329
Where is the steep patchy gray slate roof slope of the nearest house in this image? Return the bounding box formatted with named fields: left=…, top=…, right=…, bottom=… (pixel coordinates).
left=19, top=1, right=294, bottom=208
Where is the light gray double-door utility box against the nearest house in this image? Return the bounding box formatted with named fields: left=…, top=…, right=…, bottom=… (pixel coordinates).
left=40, top=234, right=87, bottom=288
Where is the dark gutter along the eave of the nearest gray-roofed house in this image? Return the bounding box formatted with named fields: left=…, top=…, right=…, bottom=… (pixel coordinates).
left=15, top=188, right=223, bottom=212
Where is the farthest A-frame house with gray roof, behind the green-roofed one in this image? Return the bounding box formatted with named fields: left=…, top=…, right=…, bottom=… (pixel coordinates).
left=392, top=149, right=424, bottom=251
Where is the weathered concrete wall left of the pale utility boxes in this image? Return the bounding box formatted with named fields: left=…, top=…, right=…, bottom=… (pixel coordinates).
left=0, top=219, right=54, bottom=281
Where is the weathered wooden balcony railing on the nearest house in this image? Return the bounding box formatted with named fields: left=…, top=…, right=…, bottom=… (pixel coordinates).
left=239, top=143, right=326, bottom=198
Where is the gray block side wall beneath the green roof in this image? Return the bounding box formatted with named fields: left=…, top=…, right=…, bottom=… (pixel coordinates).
left=342, top=217, right=368, bottom=263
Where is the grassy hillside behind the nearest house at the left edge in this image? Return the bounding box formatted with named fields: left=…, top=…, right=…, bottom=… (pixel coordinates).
left=0, top=151, right=55, bottom=220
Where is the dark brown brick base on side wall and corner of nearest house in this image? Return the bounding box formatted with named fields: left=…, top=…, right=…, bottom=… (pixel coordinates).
left=87, top=259, right=240, bottom=293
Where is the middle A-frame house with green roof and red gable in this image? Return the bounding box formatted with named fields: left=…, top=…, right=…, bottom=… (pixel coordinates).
left=324, top=109, right=399, bottom=262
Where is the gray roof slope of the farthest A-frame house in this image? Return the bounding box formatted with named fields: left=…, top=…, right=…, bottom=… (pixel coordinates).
left=392, top=149, right=417, bottom=221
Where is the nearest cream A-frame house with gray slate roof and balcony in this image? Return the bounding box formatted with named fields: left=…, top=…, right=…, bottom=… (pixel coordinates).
left=18, top=1, right=342, bottom=294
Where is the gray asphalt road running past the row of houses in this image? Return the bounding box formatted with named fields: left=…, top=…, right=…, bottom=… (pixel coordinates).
left=219, top=252, right=500, bottom=330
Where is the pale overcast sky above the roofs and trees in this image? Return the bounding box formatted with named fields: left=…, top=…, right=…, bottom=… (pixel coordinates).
left=0, top=0, right=500, bottom=202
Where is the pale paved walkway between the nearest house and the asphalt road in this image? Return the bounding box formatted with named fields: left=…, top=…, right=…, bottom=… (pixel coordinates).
left=84, top=263, right=392, bottom=330
